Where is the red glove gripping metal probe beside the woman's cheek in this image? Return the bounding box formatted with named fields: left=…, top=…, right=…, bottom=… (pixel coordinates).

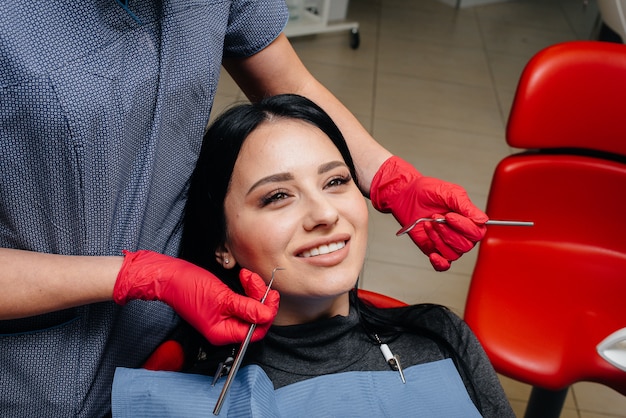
left=113, top=250, right=279, bottom=345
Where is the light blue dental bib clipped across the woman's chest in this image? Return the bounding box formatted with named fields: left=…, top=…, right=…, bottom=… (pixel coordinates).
left=112, top=359, right=480, bottom=418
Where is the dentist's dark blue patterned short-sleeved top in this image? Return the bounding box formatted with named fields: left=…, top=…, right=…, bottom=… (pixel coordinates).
left=0, top=0, right=287, bottom=417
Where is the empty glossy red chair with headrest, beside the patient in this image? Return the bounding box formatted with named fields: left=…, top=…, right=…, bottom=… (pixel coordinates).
left=465, top=41, right=626, bottom=417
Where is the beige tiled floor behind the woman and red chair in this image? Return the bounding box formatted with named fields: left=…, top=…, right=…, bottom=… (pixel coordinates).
left=214, top=0, right=626, bottom=418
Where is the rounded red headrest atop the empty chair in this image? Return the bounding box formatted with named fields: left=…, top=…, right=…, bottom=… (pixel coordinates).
left=507, top=41, right=626, bottom=155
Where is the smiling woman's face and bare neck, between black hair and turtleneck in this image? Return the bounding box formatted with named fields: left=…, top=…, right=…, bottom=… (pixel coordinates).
left=225, top=119, right=367, bottom=325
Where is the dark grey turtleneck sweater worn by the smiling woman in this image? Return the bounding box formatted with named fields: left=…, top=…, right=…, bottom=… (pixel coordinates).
left=246, top=305, right=515, bottom=418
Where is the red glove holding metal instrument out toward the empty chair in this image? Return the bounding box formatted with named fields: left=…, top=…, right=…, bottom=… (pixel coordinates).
left=370, top=156, right=489, bottom=271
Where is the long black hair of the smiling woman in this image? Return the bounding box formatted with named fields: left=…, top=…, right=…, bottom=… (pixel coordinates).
left=180, top=94, right=358, bottom=292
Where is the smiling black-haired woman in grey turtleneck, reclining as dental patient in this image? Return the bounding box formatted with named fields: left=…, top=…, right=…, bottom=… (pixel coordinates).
left=113, top=95, right=514, bottom=417
